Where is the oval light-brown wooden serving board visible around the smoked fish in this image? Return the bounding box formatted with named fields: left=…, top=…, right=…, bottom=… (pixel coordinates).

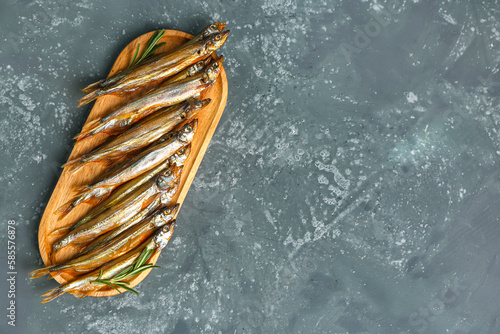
left=38, top=30, right=227, bottom=297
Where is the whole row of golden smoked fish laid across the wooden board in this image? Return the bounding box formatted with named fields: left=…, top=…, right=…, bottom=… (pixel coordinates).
left=30, top=23, right=229, bottom=302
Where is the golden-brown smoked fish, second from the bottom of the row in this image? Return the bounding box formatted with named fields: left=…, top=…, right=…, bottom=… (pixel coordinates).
left=31, top=205, right=179, bottom=278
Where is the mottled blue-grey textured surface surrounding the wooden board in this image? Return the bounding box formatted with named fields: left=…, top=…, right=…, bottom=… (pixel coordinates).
left=0, top=0, right=500, bottom=334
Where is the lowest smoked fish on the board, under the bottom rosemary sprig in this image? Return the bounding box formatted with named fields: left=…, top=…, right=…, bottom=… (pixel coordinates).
left=38, top=221, right=175, bottom=303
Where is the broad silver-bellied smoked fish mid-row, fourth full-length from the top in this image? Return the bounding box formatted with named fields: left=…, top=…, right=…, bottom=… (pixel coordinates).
left=58, top=120, right=198, bottom=218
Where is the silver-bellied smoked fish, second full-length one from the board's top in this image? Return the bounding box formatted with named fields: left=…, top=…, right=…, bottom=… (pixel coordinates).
left=77, top=57, right=222, bottom=141
